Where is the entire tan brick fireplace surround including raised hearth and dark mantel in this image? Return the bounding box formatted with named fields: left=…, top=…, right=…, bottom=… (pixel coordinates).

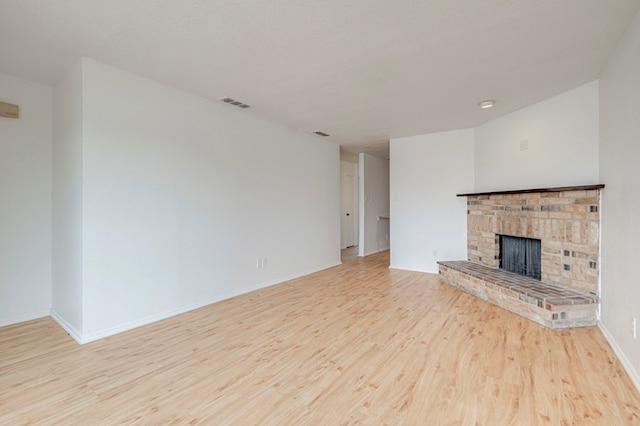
left=438, top=185, right=604, bottom=329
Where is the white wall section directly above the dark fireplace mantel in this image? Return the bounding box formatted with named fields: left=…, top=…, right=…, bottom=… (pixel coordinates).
left=475, top=81, right=599, bottom=191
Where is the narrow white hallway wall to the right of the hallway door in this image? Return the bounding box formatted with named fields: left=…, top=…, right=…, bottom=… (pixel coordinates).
left=358, top=153, right=390, bottom=256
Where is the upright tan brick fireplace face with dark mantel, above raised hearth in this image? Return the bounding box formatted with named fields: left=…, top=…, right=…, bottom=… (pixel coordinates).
left=460, top=185, right=604, bottom=295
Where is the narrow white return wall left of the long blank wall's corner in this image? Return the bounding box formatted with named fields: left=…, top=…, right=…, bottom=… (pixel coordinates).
left=51, top=62, right=84, bottom=340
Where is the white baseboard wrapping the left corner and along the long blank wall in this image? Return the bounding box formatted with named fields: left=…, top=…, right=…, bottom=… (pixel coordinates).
left=56, top=262, right=340, bottom=345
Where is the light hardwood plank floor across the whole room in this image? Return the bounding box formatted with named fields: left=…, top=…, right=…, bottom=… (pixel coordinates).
left=0, top=248, right=640, bottom=425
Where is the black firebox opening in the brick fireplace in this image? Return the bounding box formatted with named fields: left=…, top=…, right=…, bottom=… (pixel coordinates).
left=499, top=235, right=542, bottom=280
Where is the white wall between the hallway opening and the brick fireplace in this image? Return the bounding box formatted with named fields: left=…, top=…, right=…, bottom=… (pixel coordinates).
left=391, top=129, right=474, bottom=273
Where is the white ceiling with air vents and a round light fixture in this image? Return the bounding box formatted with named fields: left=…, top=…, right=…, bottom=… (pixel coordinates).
left=0, top=0, right=640, bottom=156
